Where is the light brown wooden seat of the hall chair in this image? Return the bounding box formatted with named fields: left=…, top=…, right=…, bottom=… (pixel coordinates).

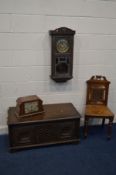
left=85, top=105, right=114, bottom=118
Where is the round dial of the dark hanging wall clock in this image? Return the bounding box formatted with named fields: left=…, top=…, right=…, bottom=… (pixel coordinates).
left=56, top=38, right=69, bottom=53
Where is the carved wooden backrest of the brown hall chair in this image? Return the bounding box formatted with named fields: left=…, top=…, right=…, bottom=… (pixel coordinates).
left=86, top=75, right=110, bottom=105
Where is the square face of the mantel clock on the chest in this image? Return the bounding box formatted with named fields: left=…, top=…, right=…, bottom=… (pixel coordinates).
left=24, top=101, right=39, bottom=114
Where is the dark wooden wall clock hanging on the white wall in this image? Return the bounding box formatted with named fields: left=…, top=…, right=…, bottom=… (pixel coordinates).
left=50, top=27, right=75, bottom=82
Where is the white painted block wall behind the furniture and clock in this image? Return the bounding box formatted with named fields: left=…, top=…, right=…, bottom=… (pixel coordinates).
left=0, top=0, right=116, bottom=133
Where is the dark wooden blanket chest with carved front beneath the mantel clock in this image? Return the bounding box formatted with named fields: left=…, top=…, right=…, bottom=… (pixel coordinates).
left=8, top=103, right=81, bottom=151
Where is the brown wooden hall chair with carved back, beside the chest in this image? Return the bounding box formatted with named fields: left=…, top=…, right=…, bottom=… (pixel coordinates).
left=84, top=75, right=114, bottom=139
